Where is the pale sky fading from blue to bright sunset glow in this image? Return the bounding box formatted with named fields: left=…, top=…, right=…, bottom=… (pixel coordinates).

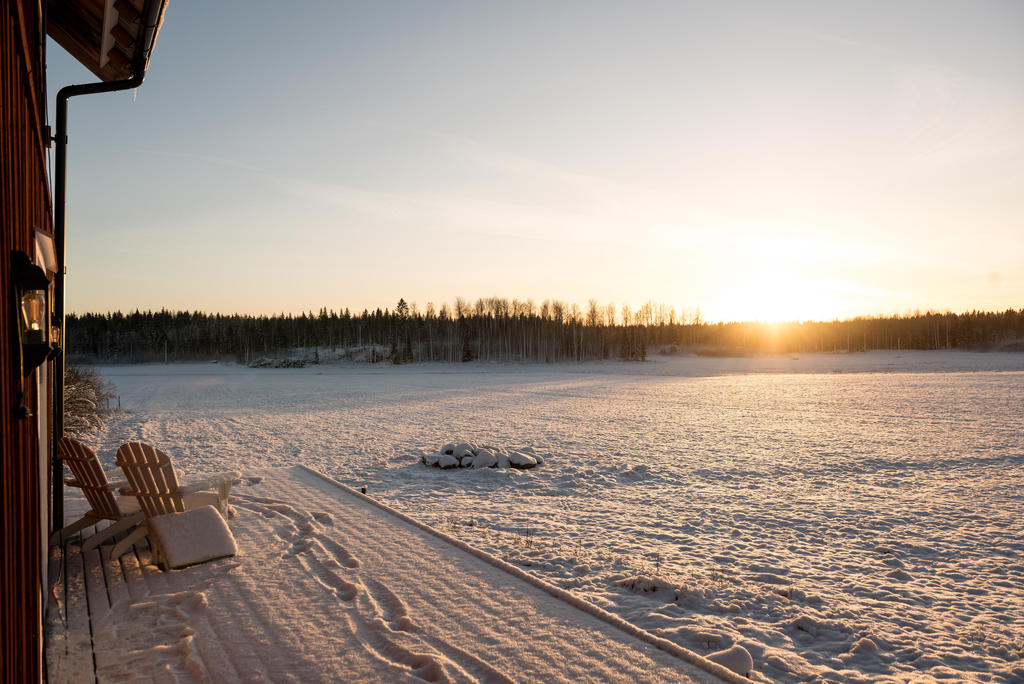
left=47, top=0, right=1024, bottom=320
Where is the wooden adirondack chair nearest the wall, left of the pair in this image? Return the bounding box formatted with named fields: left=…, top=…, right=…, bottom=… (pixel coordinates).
left=50, top=437, right=145, bottom=551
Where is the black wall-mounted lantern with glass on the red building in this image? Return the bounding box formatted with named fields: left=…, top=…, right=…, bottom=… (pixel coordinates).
left=10, top=251, right=55, bottom=418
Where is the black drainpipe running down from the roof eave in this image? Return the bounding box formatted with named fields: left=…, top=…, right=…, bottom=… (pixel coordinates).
left=50, top=0, right=167, bottom=531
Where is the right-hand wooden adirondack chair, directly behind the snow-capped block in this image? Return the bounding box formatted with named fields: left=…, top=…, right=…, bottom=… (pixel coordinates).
left=111, top=441, right=242, bottom=563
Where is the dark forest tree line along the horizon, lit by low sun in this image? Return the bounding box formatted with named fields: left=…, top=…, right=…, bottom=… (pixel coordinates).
left=67, top=297, right=1024, bottom=364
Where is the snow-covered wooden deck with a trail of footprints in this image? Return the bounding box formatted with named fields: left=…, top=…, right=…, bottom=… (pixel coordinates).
left=47, top=467, right=745, bottom=682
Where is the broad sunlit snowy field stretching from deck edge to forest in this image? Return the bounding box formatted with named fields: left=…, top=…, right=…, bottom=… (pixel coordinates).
left=86, top=352, right=1024, bottom=682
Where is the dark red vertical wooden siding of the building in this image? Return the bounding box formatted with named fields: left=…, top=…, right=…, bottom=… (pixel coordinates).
left=0, top=0, right=52, bottom=682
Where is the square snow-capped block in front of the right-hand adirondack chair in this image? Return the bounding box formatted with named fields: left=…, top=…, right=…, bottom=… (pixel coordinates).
left=146, top=506, right=239, bottom=568
